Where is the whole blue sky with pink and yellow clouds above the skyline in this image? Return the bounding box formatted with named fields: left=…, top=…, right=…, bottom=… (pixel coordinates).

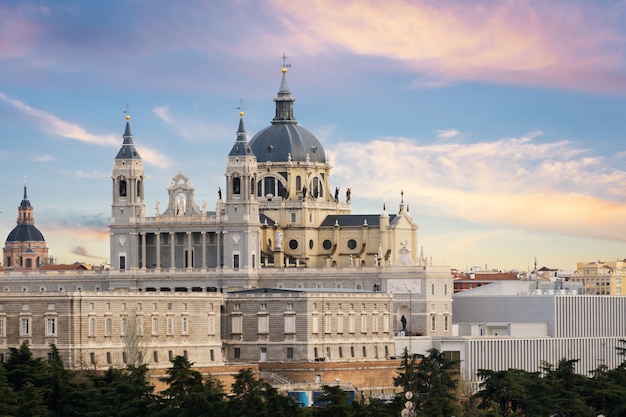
left=0, top=0, right=626, bottom=271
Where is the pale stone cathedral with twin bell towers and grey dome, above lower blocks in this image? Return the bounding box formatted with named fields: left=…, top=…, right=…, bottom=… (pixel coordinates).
left=111, top=68, right=424, bottom=279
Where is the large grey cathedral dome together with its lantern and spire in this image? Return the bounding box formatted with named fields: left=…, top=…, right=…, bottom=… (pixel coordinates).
left=250, top=68, right=326, bottom=163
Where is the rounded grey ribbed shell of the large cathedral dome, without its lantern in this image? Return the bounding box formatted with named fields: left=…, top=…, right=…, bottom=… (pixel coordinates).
left=250, top=123, right=326, bottom=163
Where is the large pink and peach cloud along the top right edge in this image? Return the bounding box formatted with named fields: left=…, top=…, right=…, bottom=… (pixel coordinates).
left=273, top=0, right=626, bottom=93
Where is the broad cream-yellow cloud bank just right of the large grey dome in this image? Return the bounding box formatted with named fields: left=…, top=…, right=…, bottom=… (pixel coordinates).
left=327, top=132, right=626, bottom=239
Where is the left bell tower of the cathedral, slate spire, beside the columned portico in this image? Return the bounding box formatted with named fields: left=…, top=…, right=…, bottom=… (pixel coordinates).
left=110, top=115, right=146, bottom=269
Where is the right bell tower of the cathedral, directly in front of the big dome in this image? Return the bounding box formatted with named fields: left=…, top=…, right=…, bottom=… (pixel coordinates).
left=224, top=112, right=260, bottom=270
